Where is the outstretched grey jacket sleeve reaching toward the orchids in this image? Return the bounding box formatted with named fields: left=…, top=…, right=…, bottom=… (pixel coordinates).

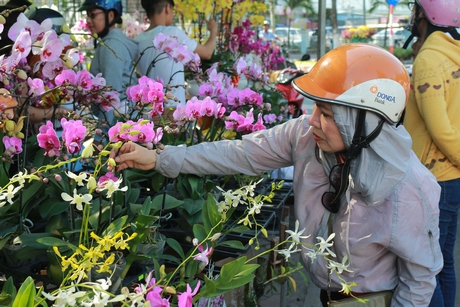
left=155, top=117, right=306, bottom=177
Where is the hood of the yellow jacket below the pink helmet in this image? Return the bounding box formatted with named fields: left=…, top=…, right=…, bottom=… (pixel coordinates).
left=419, top=31, right=460, bottom=66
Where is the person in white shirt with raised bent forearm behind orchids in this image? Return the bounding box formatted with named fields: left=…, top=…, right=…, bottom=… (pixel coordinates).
left=135, top=0, right=217, bottom=110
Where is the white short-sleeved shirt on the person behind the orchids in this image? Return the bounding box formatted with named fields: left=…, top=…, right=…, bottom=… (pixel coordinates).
left=134, top=26, right=198, bottom=107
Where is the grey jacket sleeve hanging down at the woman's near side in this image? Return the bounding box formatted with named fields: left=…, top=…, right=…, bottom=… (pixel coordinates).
left=389, top=166, right=443, bottom=307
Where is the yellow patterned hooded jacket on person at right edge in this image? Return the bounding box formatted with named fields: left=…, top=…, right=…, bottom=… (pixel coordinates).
left=404, top=32, right=460, bottom=181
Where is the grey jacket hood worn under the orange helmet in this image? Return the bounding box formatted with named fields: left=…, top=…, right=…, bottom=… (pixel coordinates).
left=320, top=105, right=412, bottom=206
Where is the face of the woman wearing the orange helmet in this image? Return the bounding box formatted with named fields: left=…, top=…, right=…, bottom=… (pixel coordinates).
left=308, top=101, right=345, bottom=152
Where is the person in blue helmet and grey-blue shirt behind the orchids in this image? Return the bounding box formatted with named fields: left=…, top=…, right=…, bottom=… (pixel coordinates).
left=78, top=0, right=138, bottom=123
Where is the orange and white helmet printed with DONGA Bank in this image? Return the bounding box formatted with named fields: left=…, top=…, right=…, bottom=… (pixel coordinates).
left=293, top=44, right=410, bottom=123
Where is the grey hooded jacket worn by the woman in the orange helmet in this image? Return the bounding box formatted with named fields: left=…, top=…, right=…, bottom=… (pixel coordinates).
left=155, top=113, right=442, bottom=307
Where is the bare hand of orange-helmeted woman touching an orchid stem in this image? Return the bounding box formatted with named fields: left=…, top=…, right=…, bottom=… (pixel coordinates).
left=110, top=142, right=157, bottom=171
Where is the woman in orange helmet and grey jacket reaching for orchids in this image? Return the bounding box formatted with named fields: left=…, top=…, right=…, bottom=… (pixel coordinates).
left=113, top=44, right=442, bottom=307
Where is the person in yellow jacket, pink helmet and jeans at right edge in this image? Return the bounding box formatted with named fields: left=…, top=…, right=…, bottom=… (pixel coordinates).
left=404, top=0, right=460, bottom=307
